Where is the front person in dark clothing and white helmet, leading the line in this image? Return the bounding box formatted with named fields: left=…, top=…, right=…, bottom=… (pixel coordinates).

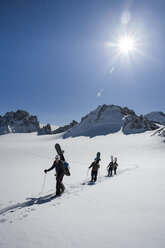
left=44, top=155, right=65, bottom=196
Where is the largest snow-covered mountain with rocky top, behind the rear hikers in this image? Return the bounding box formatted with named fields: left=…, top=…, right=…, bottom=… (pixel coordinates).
left=64, top=105, right=158, bottom=138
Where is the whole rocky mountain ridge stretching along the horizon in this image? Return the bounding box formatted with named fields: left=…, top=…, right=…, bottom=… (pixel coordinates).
left=0, top=104, right=165, bottom=138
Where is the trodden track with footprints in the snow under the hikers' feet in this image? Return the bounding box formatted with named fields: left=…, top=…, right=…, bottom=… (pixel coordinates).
left=0, top=164, right=139, bottom=224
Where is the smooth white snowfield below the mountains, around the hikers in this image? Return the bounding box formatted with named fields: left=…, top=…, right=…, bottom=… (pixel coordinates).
left=0, top=132, right=165, bottom=248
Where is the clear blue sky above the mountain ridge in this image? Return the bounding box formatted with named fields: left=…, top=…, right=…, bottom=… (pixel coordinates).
left=0, top=0, right=165, bottom=125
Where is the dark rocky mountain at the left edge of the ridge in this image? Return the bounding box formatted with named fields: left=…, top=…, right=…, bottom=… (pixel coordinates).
left=0, top=110, right=40, bottom=134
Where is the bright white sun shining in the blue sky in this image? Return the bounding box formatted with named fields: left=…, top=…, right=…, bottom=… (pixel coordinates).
left=117, top=36, right=136, bottom=55
